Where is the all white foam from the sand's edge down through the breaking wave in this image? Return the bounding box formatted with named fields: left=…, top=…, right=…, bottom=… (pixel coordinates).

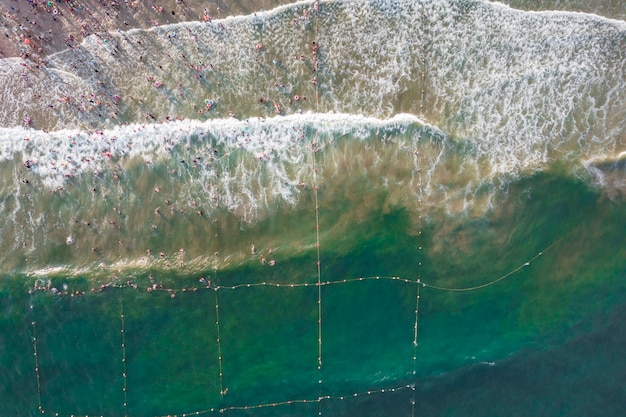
left=0, top=0, right=626, bottom=208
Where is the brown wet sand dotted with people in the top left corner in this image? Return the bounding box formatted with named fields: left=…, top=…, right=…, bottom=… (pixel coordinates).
left=0, top=0, right=296, bottom=62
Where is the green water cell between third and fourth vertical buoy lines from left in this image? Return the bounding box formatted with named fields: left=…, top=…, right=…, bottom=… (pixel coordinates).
left=219, top=287, right=317, bottom=405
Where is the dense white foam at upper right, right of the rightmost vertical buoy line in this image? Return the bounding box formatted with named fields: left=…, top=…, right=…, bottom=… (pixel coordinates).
left=427, top=2, right=626, bottom=172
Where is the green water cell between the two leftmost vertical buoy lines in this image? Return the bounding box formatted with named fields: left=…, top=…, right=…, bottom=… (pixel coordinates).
left=33, top=294, right=123, bottom=415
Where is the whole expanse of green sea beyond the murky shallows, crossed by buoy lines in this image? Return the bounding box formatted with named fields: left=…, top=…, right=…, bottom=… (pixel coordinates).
left=2, top=170, right=626, bottom=415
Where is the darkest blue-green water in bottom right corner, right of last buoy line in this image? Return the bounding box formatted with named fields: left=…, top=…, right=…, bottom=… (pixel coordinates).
left=416, top=286, right=626, bottom=416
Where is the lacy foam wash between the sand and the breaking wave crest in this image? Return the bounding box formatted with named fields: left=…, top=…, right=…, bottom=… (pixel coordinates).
left=2, top=0, right=624, bottom=136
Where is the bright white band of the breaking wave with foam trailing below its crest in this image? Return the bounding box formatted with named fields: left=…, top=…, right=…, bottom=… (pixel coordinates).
left=0, top=113, right=421, bottom=188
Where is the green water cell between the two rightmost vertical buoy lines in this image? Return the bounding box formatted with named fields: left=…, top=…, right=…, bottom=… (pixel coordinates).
left=322, top=281, right=415, bottom=395
